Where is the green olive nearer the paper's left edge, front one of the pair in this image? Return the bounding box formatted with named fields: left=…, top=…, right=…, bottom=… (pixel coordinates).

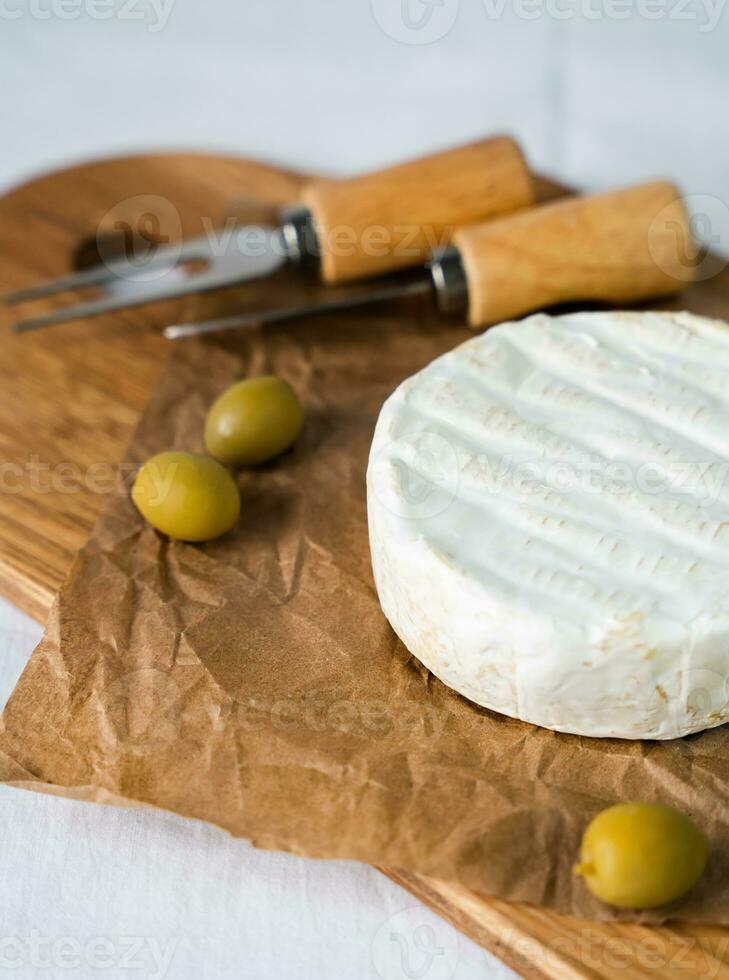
left=132, top=452, right=240, bottom=541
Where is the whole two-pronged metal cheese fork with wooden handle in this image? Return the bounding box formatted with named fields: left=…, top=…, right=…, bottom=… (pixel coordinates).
left=5, top=136, right=534, bottom=332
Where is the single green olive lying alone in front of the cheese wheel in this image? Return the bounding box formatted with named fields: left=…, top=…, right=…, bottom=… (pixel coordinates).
left=575, top=803, right=709, bottom=909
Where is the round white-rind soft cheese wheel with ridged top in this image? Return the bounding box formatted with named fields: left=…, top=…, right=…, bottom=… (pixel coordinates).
left=367, top=312, right=729, bottom=739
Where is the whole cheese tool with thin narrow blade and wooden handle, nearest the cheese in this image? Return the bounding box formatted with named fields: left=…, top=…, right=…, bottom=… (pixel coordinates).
left=164, top=181, right=695, bottom=340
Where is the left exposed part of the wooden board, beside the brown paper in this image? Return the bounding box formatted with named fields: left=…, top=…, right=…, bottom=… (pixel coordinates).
left=0, top=155, right=303, bottom=620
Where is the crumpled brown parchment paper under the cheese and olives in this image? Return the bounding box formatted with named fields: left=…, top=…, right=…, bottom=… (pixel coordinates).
left=0, top=286, right=729, bottom=923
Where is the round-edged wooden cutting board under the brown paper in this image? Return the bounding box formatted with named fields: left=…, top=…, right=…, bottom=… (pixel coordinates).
left=0, top=155, right=729, bottom=980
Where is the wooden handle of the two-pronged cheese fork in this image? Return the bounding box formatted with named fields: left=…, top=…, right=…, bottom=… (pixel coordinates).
left=303, top=137, right=533, bottom=283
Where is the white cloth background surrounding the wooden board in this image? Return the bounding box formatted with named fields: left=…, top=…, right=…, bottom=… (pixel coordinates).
left=0, top=0, right=729, bottom=980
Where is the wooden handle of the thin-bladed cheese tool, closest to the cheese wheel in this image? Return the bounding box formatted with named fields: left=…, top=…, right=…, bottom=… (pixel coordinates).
left=454, top=181, right=695, bottom=327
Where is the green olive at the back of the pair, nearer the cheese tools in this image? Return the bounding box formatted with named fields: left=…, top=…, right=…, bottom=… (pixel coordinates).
left=205, top=375, right=304, bottom=466
